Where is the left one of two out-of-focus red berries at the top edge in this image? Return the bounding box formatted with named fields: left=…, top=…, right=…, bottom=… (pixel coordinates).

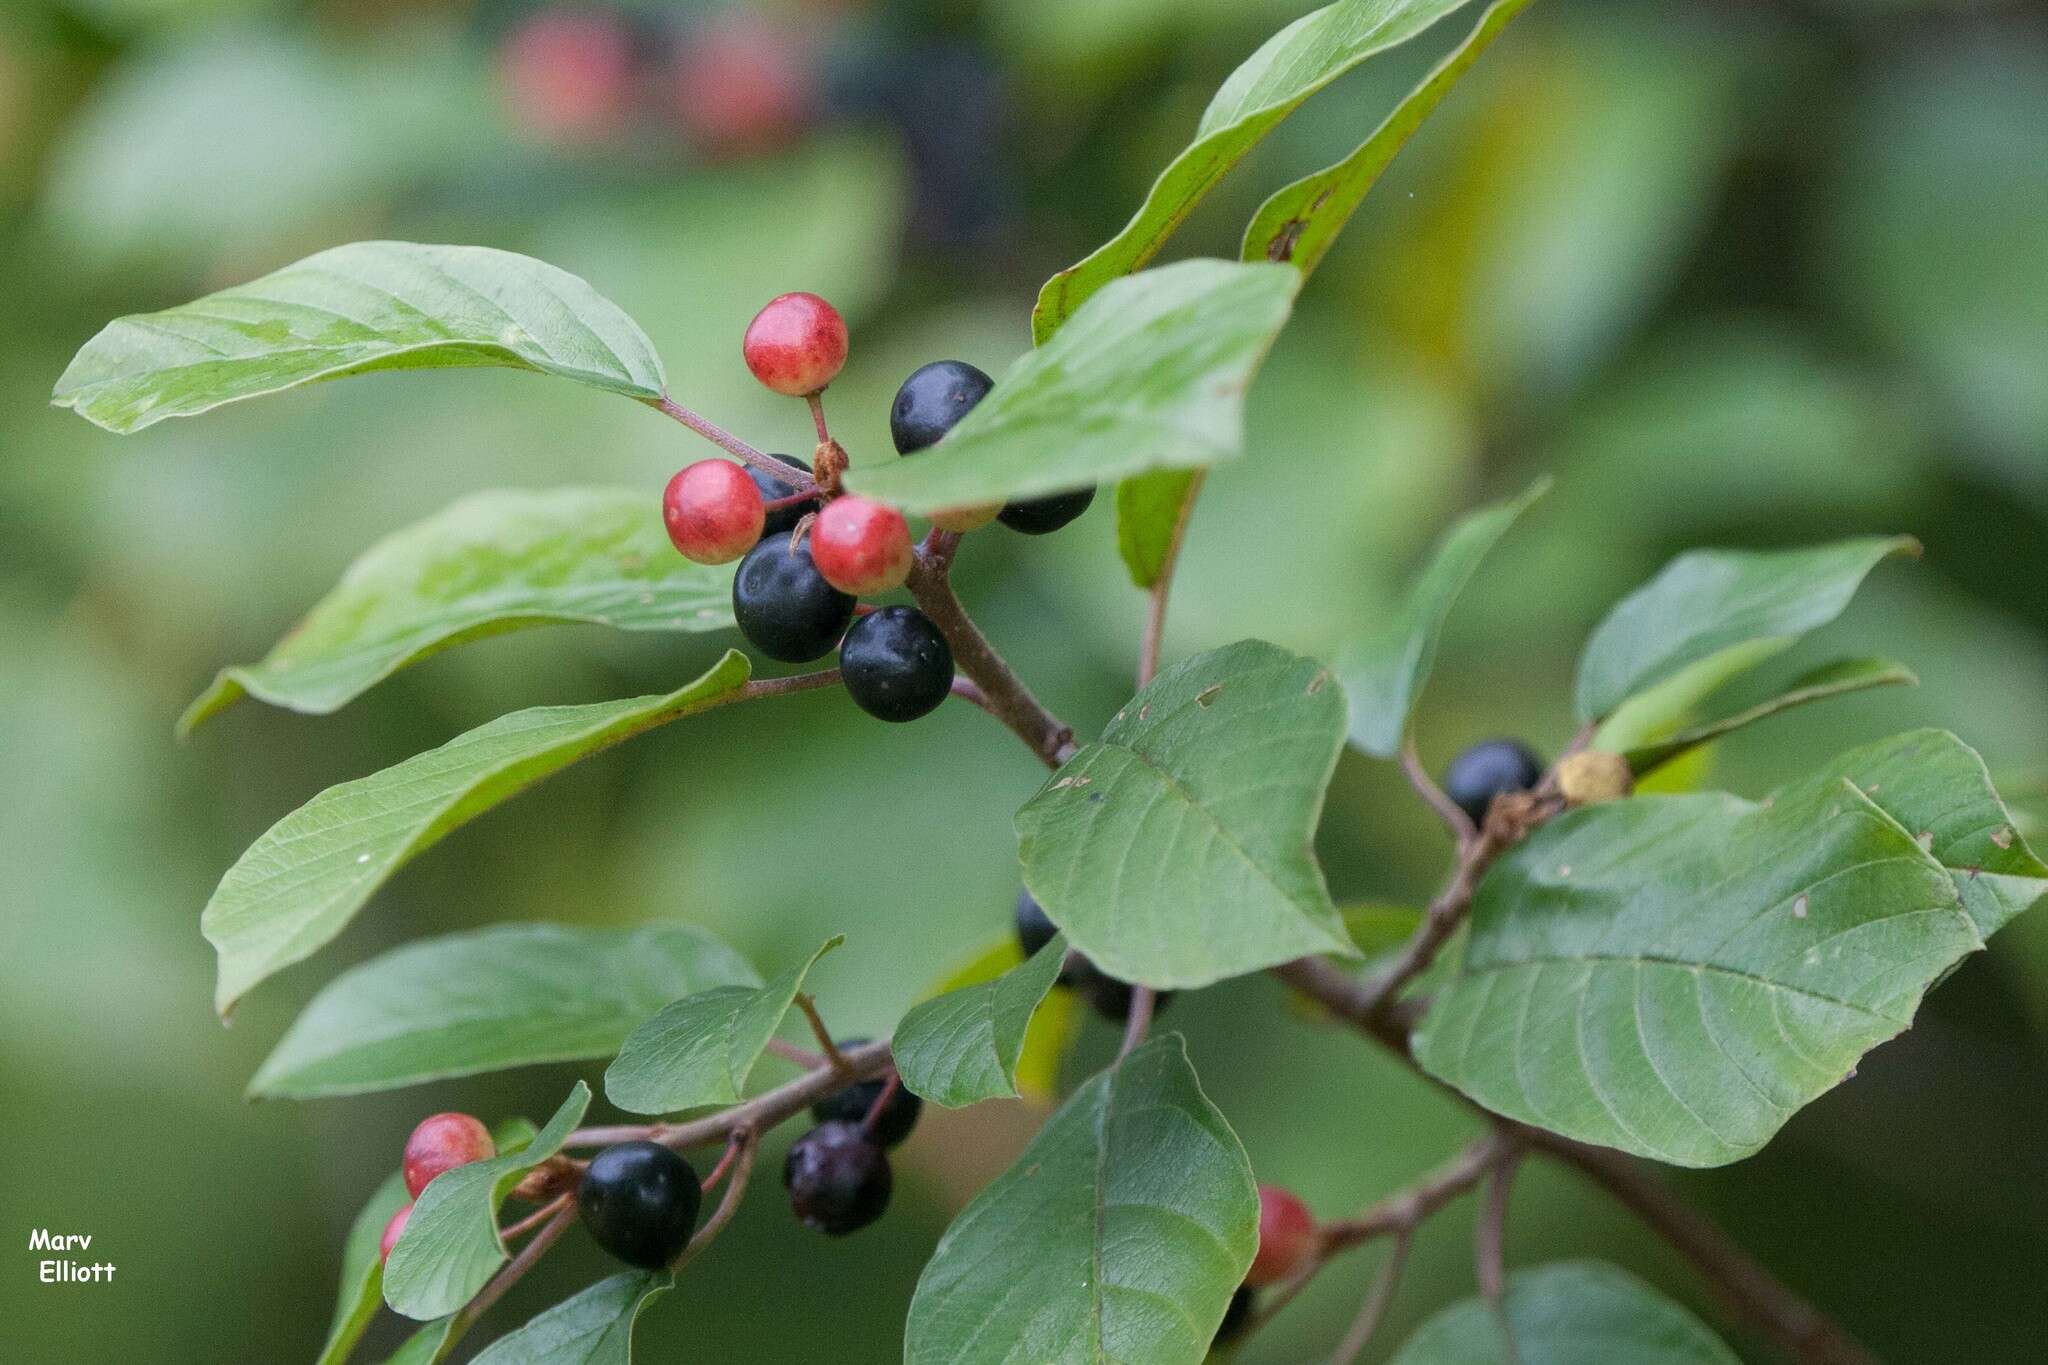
left=500, top=10, right=633, bottom=143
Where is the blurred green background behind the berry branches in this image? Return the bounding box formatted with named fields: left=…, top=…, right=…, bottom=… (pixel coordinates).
left=0, top=0, right=2048, bottom=1365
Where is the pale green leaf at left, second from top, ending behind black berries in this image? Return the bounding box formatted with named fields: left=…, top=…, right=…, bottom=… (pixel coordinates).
left=178, top=489, right=733, bottom=735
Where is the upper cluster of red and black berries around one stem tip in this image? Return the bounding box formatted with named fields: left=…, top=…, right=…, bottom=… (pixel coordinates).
left=662, top=293, right=1096, bottom=720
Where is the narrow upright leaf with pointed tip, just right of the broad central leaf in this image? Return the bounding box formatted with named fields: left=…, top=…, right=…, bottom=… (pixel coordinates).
left=1337, top=479, right=1550, bottom=759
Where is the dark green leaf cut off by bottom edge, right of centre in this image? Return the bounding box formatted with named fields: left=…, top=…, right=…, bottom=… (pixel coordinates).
left=1391, top=1261, right=1743, bottom=1365
